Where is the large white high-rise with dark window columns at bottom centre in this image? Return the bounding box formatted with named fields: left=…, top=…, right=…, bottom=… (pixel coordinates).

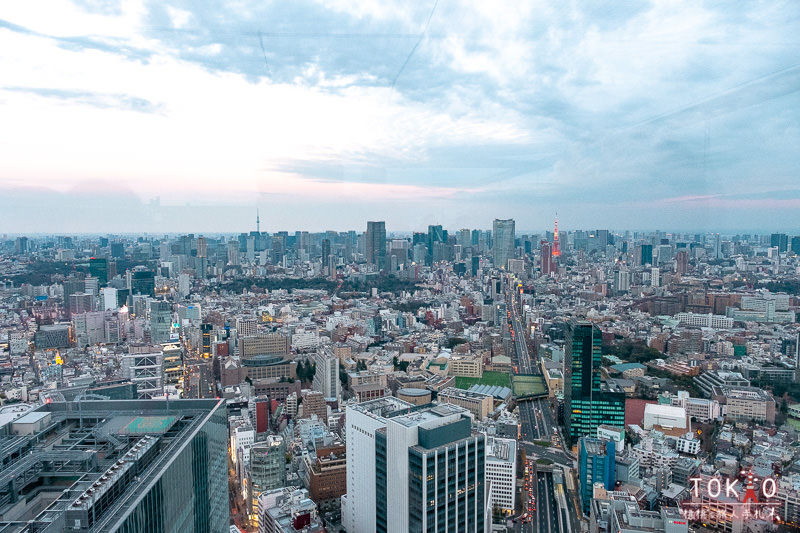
left=342, top=397, right=486, bottom=533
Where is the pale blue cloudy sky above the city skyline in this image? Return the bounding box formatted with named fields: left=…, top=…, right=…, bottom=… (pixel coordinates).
left=0, top=0, right=800, bottom=234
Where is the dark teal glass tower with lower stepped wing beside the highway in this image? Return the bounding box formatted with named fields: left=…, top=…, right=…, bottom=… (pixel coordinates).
left=564, top=320, right=625, bottom=444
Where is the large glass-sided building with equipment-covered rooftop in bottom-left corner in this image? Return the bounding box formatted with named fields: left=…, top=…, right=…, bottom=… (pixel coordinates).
left=0, top=400, right=229, bottom=533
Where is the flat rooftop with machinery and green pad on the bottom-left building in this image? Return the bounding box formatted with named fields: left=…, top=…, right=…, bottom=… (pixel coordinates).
left=0, top=400, right=224, bottom=531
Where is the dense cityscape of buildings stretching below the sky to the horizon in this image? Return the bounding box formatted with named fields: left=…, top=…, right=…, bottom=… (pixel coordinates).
left=0, top=218, right=800, bottom=533
